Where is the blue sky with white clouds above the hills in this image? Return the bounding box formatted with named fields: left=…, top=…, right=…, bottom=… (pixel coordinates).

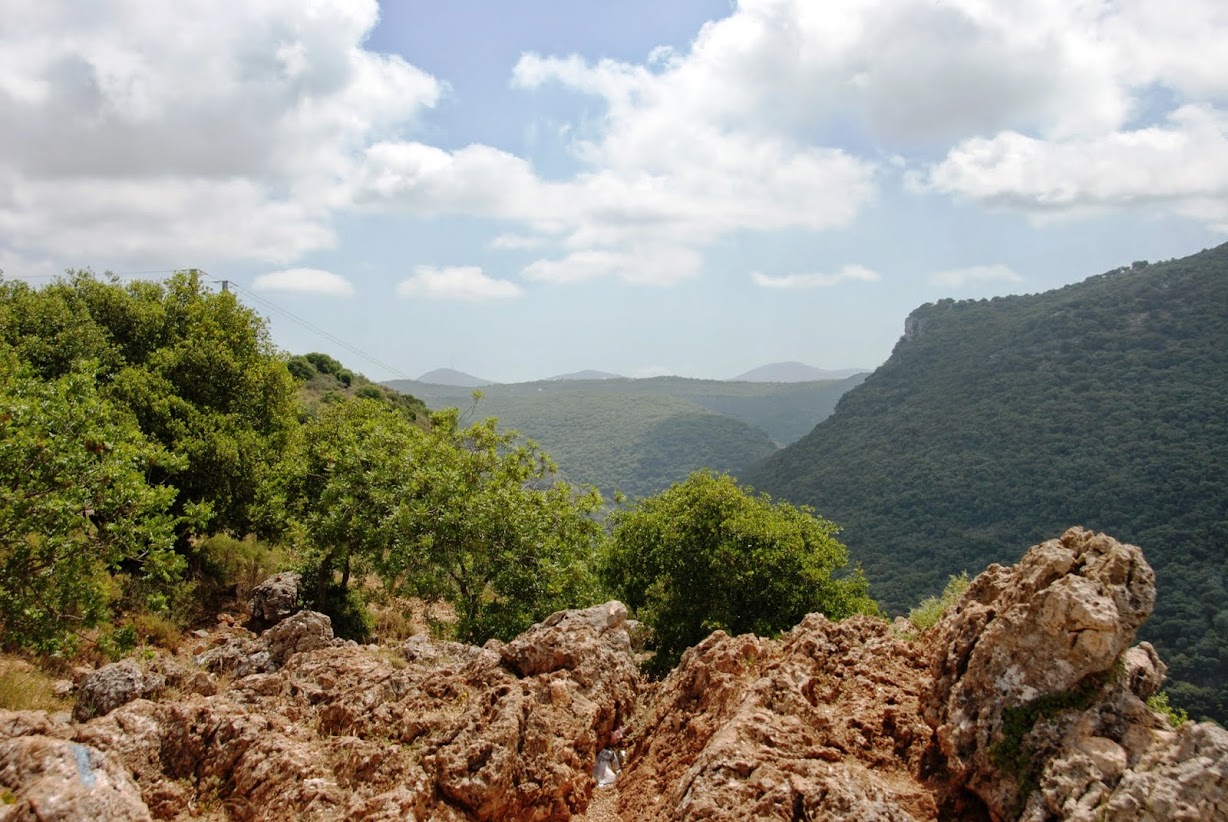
left=0, top=0, right=1228, bottom=382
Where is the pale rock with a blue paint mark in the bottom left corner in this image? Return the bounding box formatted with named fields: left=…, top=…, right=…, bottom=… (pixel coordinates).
left=0, top=732, right=152, bottom=822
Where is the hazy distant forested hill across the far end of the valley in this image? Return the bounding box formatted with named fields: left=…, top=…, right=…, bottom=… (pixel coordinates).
left=386, top=377, right=861, bottom=496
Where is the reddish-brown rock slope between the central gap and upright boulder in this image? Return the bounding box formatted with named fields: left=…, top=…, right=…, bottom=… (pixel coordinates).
left=619, top=614, right=938, bottom=820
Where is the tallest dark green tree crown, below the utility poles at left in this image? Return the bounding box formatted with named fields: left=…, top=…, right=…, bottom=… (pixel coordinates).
left=0, top=272, right=296, bottom=552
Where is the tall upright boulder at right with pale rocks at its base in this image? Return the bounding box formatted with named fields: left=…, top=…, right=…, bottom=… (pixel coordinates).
left=925, top=528, right=1228, bottom=822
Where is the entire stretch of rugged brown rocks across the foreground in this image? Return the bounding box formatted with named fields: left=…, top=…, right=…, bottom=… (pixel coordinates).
left=0, top=530, right=1228, bottom=821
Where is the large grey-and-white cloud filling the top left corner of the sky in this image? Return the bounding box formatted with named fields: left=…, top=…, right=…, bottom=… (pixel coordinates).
left=0, top=0, right=442, bottom=264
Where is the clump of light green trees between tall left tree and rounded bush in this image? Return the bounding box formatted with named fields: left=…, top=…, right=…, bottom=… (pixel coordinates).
left=270, top=399, right=602, bottom=641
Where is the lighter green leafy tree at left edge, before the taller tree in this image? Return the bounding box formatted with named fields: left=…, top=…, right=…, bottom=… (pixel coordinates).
left=0, top=353, right=183, bottom=652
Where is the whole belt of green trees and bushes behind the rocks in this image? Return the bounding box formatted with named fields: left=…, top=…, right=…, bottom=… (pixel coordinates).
left=0, top=272, right=877, bottom=671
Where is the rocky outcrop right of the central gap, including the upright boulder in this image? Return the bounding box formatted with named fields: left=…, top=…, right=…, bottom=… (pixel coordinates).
left=620, top=528, right=1228, bottom=822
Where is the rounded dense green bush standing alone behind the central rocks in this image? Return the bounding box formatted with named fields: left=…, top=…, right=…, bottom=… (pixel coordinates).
left=600, top=471, right=878, bottom=673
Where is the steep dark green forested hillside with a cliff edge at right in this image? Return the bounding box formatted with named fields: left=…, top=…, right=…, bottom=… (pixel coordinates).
left=745, top=246, right=1228, bottom=721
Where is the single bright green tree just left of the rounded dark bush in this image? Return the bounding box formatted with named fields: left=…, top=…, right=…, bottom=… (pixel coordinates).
left=386, top=409, right=604, bottom=643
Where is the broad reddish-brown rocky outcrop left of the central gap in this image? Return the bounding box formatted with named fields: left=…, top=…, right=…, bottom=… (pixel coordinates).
left=0, top=602, right=639, bottom=820
